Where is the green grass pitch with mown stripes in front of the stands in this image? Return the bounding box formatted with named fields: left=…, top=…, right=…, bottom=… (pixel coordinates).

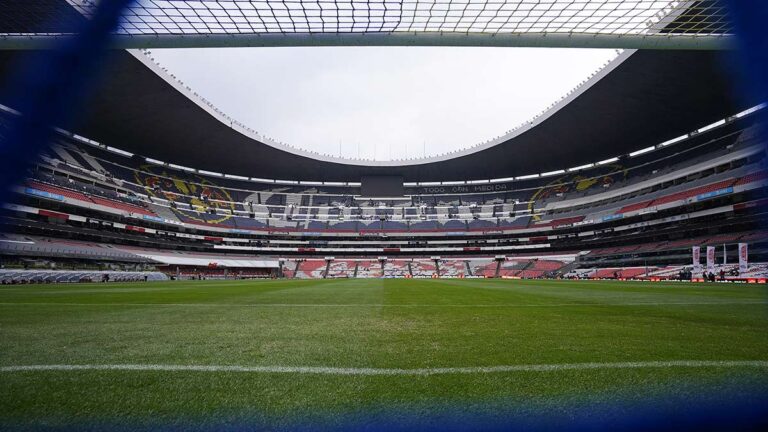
left=0, top=279, right=768, bottom=428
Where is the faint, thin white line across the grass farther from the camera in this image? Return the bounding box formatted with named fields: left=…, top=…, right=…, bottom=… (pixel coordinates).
left=0, top=300, right=768, bottom=308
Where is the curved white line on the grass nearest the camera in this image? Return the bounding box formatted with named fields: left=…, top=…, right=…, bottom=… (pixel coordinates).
left=0, top=360, right=768, bottom=376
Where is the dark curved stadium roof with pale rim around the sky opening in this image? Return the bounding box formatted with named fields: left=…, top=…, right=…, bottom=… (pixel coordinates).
left=0, top=0, right=762, bottom=181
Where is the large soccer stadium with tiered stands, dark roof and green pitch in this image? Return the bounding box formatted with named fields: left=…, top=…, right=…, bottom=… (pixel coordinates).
left=0, top=0, right=768, bottom=430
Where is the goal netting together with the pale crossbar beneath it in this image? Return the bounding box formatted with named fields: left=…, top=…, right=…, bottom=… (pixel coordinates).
left=0, top=0, right=732, bottom=49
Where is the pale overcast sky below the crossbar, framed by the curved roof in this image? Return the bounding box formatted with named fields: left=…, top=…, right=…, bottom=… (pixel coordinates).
left=152, top=47, right=616, bottom=160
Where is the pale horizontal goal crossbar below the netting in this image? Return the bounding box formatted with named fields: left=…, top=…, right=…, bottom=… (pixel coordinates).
left=0, top=32, right=735, bottom=50
